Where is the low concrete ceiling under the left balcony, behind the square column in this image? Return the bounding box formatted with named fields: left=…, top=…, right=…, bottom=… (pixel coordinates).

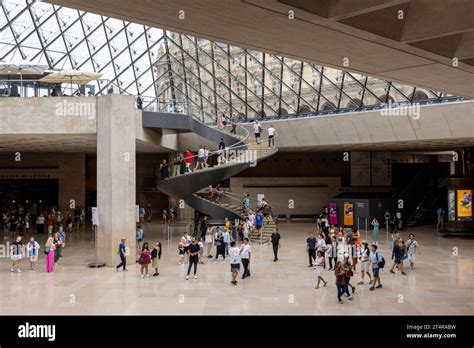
left=0, top=134, right=170, bottom=153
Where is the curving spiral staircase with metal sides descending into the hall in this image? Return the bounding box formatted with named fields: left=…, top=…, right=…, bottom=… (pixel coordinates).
left=143, top=112, right=278, bottom=239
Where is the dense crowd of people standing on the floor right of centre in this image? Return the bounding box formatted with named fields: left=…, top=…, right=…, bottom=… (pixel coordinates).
left=312, top=214, right=419, bottom=304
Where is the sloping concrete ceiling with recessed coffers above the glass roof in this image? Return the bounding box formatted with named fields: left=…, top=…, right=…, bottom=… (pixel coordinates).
left=47, top=0, right=474, bottom=97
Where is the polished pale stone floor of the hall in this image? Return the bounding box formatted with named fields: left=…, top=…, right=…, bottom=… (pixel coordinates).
left=0, top=222, right=474, bottom=315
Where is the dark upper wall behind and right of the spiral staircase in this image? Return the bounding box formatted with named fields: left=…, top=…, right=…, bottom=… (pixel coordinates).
left=237, top=152, right=351, bottom=186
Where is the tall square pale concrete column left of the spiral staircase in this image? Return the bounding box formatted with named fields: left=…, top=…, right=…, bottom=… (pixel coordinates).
left=96, top=94, right=137, bottom=266
